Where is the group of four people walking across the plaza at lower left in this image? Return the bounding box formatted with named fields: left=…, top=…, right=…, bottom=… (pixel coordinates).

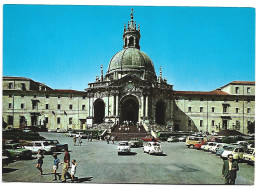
left=36, top=148, right=77, bottom=182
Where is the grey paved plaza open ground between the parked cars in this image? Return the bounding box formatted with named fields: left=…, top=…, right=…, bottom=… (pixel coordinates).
left=2, top=133, right=254, bottom=185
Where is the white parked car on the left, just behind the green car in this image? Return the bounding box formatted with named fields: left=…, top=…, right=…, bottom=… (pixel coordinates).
left=24, top=141, right=56, bottom=153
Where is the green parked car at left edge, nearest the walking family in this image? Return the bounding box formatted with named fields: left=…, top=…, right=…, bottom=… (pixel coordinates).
left=3, top=143, right=32, bottom=159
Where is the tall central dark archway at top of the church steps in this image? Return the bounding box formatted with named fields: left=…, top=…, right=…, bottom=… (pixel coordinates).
left=120, top=95, right=139, bottom=123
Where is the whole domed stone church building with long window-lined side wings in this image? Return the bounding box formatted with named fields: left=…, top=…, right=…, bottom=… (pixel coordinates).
left=3, top=12, right=255, bottom=134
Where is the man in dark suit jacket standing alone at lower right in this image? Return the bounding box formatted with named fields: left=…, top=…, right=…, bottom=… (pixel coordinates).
left=222, top=154, right=239, bottom=185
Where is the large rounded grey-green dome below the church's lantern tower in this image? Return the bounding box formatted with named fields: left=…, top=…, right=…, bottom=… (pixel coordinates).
left=107, top=48, right=155, bottom=74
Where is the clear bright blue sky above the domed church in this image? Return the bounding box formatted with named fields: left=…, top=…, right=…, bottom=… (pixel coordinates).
left=3, top=5, right=255, bottom=91
